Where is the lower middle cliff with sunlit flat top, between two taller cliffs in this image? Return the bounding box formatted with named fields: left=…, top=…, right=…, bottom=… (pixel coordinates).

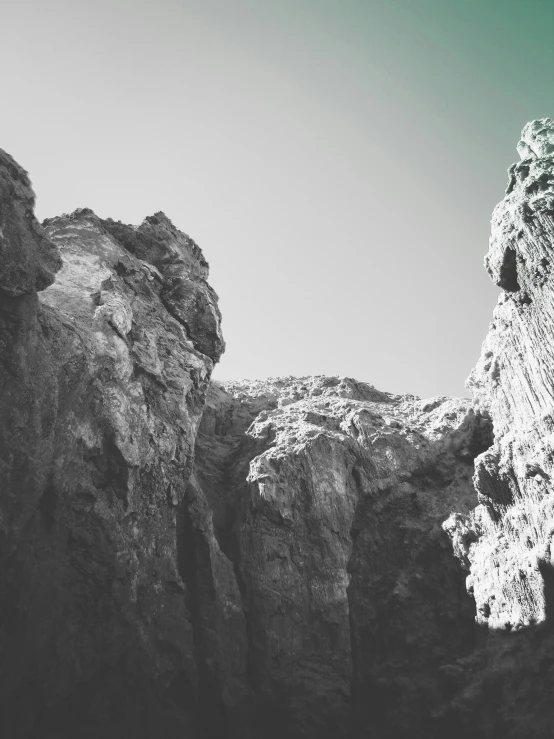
left=191, top=377, right=490, bottom=738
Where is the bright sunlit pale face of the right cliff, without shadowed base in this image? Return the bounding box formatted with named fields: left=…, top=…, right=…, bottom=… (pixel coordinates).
left=458, top=119, right=554, bottom=629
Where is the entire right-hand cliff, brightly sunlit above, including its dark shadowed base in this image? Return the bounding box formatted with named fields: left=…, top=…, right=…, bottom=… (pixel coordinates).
left=436, top=119, right=554, bottom=739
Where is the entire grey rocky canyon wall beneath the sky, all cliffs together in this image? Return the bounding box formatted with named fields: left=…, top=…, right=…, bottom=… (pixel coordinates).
left=0, top=120, right=554, bottom=739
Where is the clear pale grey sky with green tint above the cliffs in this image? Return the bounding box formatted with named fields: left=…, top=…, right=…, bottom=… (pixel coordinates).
left=0, top=0, right=554, bottom=397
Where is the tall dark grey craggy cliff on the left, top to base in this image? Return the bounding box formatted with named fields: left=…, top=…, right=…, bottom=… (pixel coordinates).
left=0, top=147, right=223, bottom=739
